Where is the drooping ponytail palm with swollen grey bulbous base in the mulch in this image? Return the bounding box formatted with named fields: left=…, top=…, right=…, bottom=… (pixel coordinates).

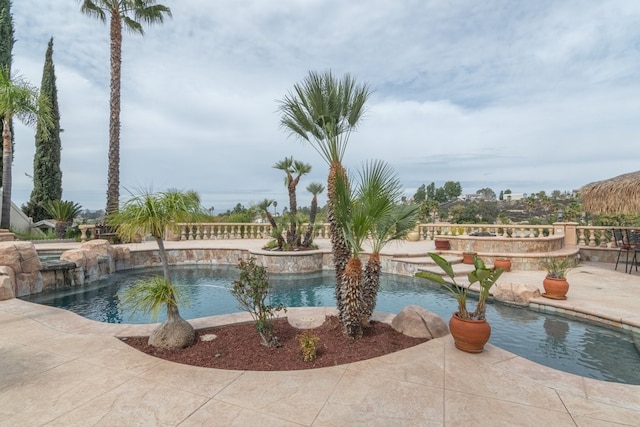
left=108, top=190, right=205, bottom=348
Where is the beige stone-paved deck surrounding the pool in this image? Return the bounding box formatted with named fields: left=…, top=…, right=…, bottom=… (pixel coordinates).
left=0, top=241, right=640, bottom=426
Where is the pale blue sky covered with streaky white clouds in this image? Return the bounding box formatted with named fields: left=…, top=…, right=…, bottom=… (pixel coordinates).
left=12, top=0, right=640, bottom=213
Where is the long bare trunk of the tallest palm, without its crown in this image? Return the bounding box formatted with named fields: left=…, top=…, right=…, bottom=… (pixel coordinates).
left=107, top=13, right=122, bottom=214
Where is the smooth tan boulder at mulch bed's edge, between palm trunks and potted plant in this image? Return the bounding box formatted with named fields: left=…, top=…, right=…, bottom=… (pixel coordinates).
left=391, top=305, right=449, bottom=339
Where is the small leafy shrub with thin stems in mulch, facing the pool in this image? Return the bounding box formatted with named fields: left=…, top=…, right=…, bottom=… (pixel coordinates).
left=231, top=258, right=287, bottom=347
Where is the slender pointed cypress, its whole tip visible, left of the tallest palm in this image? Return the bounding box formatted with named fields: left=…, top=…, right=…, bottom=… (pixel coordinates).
left=23, top=37, right=62, bottom=221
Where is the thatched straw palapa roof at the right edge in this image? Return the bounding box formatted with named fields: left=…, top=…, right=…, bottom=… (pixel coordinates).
left=580, top=171, right=640, bottom=214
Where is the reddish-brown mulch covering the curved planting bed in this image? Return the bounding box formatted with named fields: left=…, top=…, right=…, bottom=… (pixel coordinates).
left=122, top=316, right=427, bottom=371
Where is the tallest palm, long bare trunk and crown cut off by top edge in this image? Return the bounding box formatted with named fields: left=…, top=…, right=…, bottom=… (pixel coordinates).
left=80, top=0, right=171, bottom=214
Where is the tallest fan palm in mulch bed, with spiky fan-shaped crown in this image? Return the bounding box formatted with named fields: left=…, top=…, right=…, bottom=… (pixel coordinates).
left=279, top=71, right=371, bottom=316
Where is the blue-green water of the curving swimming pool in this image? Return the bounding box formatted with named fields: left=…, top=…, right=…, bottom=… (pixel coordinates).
left=23, top=266, right=640, bottom=385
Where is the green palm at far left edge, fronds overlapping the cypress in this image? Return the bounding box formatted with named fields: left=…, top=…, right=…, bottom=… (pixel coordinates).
left=0, top=68, right=53, bottom=229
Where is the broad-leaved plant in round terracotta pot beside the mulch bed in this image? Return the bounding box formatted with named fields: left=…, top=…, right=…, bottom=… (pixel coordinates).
left=416, top=253, right=503, bottom=353
